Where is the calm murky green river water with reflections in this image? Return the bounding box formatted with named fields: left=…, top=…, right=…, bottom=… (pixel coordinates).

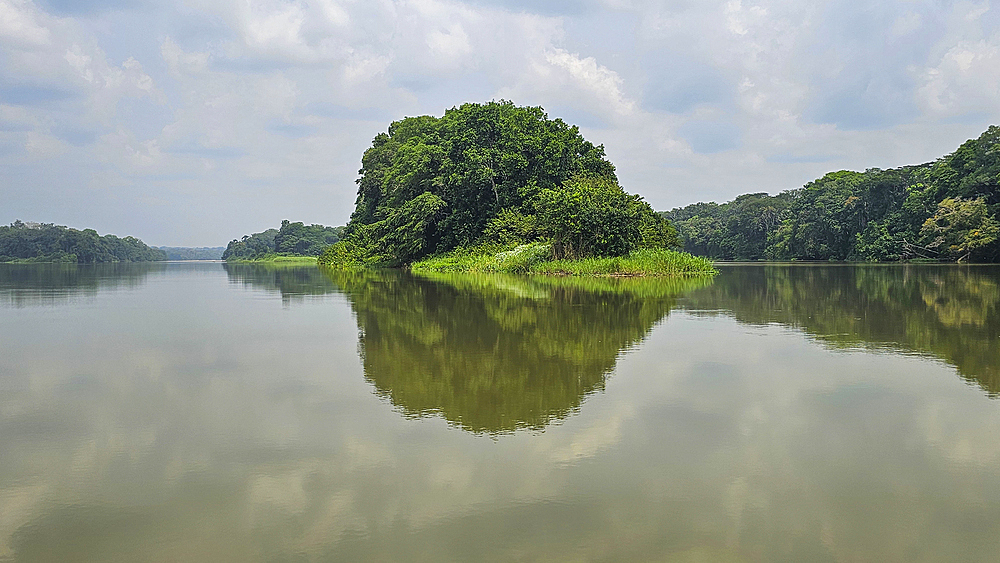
left=0, top=263, right=1000, bottom=562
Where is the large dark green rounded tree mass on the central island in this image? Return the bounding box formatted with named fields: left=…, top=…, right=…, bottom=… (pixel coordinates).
left=345, top=101, right=620, bottom=266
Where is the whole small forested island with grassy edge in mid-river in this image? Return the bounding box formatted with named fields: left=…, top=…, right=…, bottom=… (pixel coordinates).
left=319, top=101, right=715, bottom=275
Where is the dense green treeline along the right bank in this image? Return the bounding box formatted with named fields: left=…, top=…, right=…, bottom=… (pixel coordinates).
left=663, top=126, right=1000, bottom=262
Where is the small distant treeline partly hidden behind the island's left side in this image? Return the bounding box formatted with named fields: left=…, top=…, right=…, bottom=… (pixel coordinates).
left=222, top=219, right=344, bottom=260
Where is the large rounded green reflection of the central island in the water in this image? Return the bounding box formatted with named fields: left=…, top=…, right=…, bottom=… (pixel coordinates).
left=329, top=272, right=710, bottom=434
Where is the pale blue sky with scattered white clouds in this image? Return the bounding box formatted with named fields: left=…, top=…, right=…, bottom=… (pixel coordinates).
left=0, top=0, right=1000, bottom=246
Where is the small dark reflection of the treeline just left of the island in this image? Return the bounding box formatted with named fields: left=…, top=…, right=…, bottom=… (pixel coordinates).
left=222, top=262, right=337, bottom=302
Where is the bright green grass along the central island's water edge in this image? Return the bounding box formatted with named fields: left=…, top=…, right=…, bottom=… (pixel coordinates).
left=410, top=242, right=718, bottom=276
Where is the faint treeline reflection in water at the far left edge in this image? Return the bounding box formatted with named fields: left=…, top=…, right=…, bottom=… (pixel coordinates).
left=0, top=262, right=167, bottom=307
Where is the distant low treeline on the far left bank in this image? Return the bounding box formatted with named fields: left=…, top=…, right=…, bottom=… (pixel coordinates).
left=0, top=220, right=167, bottom=264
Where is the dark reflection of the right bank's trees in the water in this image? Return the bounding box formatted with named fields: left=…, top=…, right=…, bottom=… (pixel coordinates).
left=685, top=265, right=1000, bottom=397
